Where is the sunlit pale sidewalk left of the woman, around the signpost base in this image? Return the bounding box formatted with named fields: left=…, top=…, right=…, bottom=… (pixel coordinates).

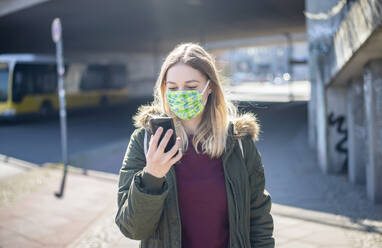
left=0, top=159, right=138, bottom=248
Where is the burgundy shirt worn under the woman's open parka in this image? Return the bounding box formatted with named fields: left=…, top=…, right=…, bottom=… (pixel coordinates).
left=174, top=137, right=229, bottom=248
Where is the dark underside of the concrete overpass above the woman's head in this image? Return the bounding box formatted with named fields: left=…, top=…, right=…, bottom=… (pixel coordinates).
left=0, top=0, right=305, bottom=54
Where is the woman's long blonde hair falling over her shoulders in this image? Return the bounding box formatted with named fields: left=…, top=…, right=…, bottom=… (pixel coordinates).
left=152, top=43, right=237, bottom=158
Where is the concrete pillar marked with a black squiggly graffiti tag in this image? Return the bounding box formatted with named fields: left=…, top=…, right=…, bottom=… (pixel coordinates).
left=326, top=86, right=348, bottom=173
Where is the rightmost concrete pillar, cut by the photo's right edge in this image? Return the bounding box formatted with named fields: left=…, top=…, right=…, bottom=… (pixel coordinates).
left=364, top=59, right=382, bottom=203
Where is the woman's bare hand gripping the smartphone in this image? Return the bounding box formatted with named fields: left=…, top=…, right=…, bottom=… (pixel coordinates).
left=144, top=127, right=183, bottom=178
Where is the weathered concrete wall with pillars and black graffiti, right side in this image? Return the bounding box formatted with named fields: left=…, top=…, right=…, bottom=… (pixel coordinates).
left=306, top=0, right=382, bottom=203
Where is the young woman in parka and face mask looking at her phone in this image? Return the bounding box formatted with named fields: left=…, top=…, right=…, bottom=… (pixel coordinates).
left=115, top=43, right=274, bottom=248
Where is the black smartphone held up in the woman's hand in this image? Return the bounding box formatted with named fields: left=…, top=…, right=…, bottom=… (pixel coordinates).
left=149, top=117, right=178, bottom=156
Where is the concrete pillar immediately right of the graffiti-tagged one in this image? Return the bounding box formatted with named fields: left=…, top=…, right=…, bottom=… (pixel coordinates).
left=347, top=77, right=367, bottom=184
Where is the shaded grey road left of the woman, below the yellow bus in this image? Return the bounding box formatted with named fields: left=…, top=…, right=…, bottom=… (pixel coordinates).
left=0, top=99, right=152, bottom=165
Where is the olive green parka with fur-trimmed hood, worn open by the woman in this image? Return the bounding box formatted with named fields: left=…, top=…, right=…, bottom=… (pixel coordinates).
left=115, top=106, right=274, bottom=248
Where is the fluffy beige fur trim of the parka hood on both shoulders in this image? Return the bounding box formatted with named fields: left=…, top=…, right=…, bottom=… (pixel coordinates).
left=133, top=105, right=260, bottom=140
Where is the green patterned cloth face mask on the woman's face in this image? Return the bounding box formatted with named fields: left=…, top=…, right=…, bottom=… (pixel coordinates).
left=166, top=80, right=210, bottom=120
